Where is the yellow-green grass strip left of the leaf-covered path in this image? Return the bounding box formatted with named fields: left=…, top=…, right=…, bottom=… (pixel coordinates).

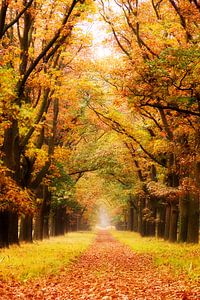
left=0, top=232, right=95, bottom=281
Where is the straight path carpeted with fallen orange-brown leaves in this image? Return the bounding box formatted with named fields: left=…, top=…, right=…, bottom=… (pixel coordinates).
left=0, top=231, right=200, bottom=300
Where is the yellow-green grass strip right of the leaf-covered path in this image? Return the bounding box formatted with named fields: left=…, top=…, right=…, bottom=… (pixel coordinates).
left=112, top=231, right=200, bottom=281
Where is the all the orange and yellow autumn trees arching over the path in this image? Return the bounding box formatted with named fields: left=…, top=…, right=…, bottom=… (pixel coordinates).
left=0, top=0, right=200, bottom=246
